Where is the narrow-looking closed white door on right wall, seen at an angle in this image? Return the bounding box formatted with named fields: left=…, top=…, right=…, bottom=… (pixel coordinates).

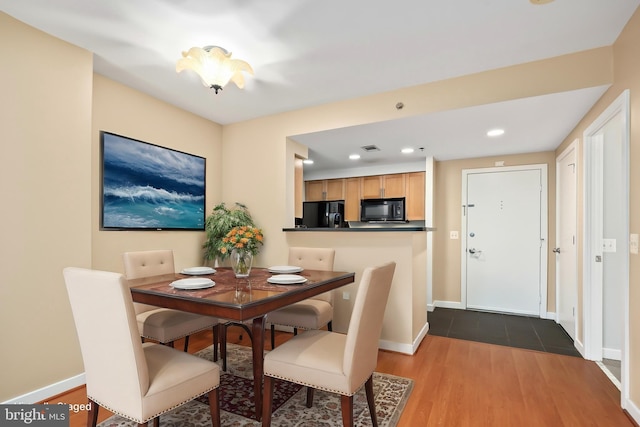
left=554, top=142, right=578, bottom=340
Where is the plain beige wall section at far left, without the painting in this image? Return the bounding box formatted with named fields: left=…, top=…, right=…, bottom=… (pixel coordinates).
left=0, top=13, right=93, bottom=402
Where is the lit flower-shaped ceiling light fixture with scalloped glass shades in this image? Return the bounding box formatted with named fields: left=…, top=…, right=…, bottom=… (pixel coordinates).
left=176, top=46, right=253, bottom=93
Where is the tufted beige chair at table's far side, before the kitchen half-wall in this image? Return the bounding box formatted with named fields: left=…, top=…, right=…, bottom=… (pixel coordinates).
left=267, top=247, right=336, bottom=349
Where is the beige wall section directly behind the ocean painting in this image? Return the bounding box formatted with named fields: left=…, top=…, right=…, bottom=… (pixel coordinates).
left=91, top=75, right=222, bottom=272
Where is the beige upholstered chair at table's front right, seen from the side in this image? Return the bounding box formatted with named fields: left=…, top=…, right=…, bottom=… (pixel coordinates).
left=262, top=262, right=396, bottom=427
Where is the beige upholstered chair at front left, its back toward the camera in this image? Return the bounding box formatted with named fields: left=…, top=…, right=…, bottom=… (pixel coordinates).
left=63, top=267, right=220, bottom=427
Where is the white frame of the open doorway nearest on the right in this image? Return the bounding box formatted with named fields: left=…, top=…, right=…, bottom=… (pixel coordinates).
left=578, top=89, right=631, bottom=409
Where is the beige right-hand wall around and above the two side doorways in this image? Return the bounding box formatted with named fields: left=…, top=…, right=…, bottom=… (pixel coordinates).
left=556, top=10, right=640, bottom=407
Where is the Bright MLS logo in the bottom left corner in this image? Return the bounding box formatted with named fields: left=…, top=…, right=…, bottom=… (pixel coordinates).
left=0, top=405, right=69, bottom=427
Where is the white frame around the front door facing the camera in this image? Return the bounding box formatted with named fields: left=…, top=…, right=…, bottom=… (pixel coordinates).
left=460, top=163, right=549, bottom=319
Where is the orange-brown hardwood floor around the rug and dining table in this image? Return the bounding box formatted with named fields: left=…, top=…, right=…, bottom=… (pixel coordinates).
left=48, top=328, right=634, bottom=427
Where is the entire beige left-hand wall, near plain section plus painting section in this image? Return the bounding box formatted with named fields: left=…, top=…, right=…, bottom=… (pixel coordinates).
left=0, top=13, right=222, bottom=401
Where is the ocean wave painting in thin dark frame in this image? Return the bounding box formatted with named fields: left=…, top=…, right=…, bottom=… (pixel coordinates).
left=100, top=131, right=206, bottom=230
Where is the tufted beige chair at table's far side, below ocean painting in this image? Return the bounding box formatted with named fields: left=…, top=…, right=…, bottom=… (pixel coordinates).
left=122, top=249, right=219, bottom=360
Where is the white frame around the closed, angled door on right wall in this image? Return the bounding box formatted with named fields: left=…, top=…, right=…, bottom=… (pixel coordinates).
left=555, top=139, right=580, bottom=342
